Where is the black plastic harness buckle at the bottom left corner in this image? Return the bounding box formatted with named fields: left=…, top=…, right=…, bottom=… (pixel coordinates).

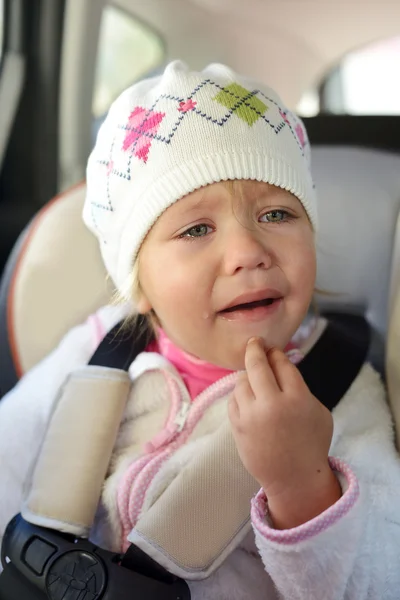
left=0, top=515, right=190, bottom=600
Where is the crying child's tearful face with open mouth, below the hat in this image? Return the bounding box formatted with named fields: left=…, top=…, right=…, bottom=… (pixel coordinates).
left=138, top=181, right=316, bottom=370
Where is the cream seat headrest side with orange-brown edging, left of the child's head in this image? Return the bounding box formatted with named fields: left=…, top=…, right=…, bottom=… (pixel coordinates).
left=0, top=184, right=113, bottom=376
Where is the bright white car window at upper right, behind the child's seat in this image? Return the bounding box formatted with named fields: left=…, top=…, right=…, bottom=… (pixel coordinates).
left=297, top=37, right=400, bottom=116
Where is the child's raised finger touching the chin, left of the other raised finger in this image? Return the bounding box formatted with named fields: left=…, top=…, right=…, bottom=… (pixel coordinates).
left=245, top=338, right=279, bottom=397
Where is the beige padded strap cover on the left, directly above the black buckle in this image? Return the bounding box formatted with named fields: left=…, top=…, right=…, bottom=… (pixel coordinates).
left=21, top=367, right=130, bottom=537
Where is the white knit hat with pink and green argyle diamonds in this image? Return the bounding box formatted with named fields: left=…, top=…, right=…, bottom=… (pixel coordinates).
left=83, top=61, right=317, bottom=294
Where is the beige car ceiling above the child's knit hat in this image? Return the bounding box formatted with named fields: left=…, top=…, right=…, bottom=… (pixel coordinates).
left=114, top=0, right=400, bottom=106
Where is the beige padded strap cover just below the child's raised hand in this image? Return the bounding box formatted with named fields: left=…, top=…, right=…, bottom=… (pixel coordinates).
left=128, top=419, right=260, bottom=580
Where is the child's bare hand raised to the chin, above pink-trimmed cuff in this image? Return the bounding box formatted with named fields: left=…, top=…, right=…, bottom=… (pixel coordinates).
left=229, top=339, right=341, bottom=528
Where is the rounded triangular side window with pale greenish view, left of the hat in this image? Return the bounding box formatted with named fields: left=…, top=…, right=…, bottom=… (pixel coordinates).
left=93, top=6, right=165, bottom=120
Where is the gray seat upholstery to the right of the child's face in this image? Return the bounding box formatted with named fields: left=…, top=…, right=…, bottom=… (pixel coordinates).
left=313, top=147, right=400, bottom=367
